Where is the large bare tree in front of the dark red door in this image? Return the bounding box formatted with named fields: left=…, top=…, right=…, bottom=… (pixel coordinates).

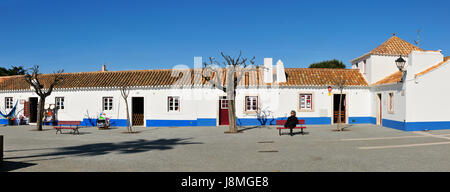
left=202, top=52, right=257, bottom=133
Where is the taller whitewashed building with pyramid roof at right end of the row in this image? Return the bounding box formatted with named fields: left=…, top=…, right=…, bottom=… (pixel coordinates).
left=352, top=34, right=450, bottom=131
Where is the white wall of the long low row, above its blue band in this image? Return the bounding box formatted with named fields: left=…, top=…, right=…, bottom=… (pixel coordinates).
left=0, top=87, right=370, bottom=124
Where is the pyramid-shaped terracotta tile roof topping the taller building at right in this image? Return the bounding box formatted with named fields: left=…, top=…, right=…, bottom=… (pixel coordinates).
left=369, top=35, right=423, bottom=56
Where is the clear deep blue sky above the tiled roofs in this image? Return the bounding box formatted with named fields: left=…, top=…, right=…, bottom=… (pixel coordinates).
left=0, top=0, right=450, bottom=73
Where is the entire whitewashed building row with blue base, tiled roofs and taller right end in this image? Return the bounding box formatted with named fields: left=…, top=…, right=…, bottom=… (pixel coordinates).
left=0, top=36, right=450, bottom=131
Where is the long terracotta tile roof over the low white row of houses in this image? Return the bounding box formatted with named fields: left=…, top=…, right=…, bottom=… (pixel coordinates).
left=0, top=68, right=367, bottom=90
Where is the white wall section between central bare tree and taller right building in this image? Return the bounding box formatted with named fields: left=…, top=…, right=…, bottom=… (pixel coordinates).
left=236, top=87, right=370, bottom=121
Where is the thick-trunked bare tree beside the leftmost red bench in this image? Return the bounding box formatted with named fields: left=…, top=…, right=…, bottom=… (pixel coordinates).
left=24, top=65, right=64, bottom=131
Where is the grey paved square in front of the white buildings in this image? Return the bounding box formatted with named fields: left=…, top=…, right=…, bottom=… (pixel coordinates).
left=0, top=125, right=450, bottom=172
